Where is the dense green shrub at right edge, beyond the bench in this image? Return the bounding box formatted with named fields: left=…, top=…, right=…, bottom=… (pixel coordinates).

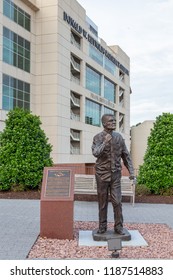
left=138, top=113, right=173, bottom=194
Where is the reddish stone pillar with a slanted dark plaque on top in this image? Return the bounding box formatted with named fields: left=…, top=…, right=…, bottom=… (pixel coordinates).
left=40, top=167, right=74, bottom=239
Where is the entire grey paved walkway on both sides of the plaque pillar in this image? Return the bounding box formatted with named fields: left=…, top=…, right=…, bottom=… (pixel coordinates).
left=0, top=199, right=173, bottom=260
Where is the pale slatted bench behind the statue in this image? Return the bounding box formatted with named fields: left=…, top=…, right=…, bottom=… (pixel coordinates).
left=74, top=174, right=135, bottom=206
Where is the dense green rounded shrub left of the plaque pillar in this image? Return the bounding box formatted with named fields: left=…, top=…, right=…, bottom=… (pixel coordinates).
left=0, top=108, right=53, bottom=190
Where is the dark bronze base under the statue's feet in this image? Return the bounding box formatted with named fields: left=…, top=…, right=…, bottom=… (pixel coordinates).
left=92, top=228, right=131, bottom=241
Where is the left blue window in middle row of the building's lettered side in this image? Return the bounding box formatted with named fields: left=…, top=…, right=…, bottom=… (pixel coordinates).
left=86, top=66, right=101, bottom=95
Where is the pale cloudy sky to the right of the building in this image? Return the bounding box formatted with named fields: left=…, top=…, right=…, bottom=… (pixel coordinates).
left=78, top=0, right=173, bottom=125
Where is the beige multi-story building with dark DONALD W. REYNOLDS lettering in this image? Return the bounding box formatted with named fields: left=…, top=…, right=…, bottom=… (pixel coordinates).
left=0, top=0, right=131, bottom=170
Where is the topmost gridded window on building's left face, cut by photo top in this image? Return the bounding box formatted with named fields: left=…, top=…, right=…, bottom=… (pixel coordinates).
left=3, top=0, right=31, bottom=31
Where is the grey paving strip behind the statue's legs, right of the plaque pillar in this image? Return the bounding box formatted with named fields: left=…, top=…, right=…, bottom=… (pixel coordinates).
left=75, top=201, right=173, bottom=228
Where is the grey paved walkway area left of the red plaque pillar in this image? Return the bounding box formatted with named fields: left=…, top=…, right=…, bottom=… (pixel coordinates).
left=0, top=199, right=40, bottom=260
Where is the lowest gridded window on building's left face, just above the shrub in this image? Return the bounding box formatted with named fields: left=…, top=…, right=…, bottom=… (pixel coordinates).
left=2, top=74, right=30, bottom=110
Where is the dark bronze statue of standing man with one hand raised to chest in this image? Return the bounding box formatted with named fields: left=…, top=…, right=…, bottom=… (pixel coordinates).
left=92, top=114, right=134, bottom=234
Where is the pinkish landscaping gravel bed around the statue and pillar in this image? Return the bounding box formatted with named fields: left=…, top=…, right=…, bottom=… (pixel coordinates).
left=28, top=222, right=173, bottom=259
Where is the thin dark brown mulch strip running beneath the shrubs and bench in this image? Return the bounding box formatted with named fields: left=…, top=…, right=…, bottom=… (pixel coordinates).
left=0, top=191, right=173, bottom=204
